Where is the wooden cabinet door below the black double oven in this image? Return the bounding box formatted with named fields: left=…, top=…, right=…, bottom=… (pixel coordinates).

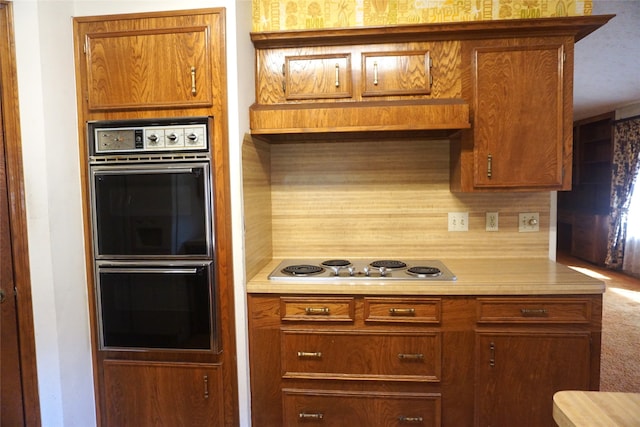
left=103, top=360, right=224, bottom=427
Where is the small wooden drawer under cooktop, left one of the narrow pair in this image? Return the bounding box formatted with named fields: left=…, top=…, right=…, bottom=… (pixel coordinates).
left=280, top=297, right=355, bottom=322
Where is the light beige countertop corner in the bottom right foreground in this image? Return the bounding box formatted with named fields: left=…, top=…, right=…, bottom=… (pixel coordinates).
left=553, top=391, right=640, bottom=427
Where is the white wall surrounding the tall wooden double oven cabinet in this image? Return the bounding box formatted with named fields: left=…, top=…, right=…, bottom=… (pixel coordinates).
left=14, top=0, right=254, bottom=427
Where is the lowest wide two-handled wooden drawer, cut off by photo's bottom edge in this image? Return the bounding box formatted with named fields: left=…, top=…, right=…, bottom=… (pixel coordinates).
left=282, top=389, right=441, bottom=427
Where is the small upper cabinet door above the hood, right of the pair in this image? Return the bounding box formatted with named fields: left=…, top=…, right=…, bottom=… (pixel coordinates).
left=362, top=51, right=431, bottom=97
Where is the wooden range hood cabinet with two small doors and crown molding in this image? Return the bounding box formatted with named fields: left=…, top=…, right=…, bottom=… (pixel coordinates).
left=250, top=16, right=611, bottom=142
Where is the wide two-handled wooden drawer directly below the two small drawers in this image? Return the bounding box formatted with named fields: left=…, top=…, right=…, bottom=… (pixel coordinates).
left=281, top=330, right=442, bottom=382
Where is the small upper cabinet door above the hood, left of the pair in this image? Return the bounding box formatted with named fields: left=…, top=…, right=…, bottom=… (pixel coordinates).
left=283, top=54, right=353, bottom=100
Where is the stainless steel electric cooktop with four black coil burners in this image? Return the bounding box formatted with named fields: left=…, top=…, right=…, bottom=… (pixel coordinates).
left=269, top=258, right=456, bottom=283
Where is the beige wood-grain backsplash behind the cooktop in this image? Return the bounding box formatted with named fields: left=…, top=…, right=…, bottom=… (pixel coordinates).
left=262, top=141, right=550, bottom=259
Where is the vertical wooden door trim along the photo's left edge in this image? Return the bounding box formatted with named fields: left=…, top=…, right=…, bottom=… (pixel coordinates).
left=0, top=1, right=41, bottom=427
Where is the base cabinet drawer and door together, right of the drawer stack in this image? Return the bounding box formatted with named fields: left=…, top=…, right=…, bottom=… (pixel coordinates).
left=475, top=297, right=600, bottom=427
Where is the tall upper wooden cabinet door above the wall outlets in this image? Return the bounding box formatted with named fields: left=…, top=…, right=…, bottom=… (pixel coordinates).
left=471, top=39, right=571, bottom=190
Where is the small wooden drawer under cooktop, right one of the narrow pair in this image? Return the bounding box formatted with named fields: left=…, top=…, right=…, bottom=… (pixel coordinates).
left=364, top=298, right=442, bottom=324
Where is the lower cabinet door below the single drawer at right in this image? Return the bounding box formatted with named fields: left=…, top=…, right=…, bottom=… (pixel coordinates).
left=475, top=332, right=591, bottom=427
